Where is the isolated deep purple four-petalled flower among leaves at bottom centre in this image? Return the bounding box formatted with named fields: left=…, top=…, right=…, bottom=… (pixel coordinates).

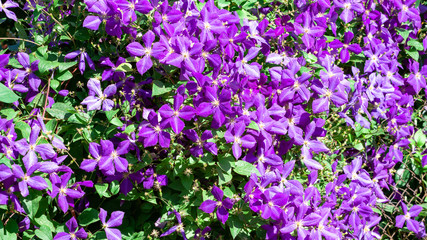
left=199, top=186, right=234, bottom=224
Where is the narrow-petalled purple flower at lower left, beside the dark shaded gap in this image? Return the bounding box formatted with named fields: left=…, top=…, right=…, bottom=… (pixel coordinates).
left=51, top=172, right=84, bottom=213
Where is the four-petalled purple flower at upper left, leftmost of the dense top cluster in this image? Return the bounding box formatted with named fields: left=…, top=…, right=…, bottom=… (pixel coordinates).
left=126, top=31, right=161, bottom=75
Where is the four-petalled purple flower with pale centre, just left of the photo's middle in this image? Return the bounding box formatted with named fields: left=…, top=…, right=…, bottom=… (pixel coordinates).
left=159, top=94, right=195, bottom=134
